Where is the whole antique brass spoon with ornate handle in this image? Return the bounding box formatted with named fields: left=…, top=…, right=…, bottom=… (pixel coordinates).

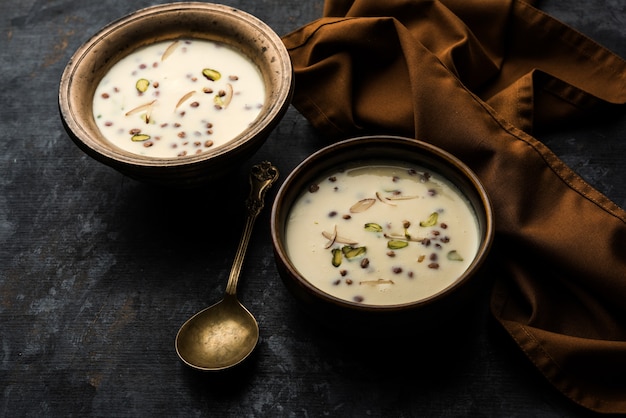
left=176, top=161, right=278, bottom=371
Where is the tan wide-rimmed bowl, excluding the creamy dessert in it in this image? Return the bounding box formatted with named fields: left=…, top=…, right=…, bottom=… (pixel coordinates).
left=59, top=2, right=294, bottom=187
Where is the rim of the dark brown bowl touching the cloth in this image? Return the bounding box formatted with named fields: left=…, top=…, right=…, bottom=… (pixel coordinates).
left=270, top=135, right=495, bottom=313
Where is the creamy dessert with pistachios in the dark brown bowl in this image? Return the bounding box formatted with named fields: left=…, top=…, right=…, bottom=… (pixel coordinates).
left=285, top=162, right=479, bottom=305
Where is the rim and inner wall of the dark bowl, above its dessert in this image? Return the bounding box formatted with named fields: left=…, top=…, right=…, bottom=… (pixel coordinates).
left=271, top=137, right=493, bottom=311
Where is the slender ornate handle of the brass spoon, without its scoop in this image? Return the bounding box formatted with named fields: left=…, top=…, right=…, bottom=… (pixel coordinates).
left=226, top=161, right=278, bottom=296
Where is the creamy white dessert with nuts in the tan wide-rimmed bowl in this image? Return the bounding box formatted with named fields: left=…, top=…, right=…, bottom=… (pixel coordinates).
left=93, top=39, right=265, bottom=158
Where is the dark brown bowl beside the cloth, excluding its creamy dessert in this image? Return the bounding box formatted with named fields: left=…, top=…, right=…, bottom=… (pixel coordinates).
left=271, top=136, right=494, bottom=335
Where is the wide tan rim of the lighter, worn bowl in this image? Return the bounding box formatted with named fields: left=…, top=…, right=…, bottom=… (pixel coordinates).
left=58, top=1, right=295, bottom=168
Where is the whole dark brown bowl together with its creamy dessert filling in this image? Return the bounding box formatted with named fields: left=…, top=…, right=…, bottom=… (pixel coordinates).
left=271, top=136, right=494, bottom=335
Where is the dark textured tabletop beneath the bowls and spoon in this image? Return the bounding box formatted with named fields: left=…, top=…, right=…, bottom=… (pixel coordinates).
left=0, top=0, right=626, bottom=417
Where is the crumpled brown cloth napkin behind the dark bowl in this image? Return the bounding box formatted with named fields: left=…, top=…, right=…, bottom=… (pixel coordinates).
left=283, top=0, right=626, bottom=413
